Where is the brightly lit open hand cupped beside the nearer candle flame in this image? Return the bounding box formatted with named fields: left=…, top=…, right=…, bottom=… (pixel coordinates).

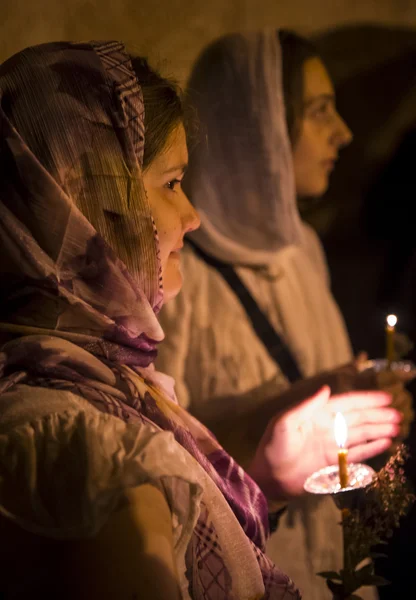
left=247, top=387, right=400, bottom=502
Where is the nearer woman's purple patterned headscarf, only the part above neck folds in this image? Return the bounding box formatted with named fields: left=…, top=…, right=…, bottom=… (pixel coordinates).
left=0, top=42, right=163, bottom=366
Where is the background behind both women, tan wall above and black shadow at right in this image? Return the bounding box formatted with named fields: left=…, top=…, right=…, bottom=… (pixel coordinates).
left=0, top=0, right=416, bottom=599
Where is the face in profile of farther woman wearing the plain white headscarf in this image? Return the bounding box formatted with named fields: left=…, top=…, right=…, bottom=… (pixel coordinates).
left=293, top=58, right=352, bottom=197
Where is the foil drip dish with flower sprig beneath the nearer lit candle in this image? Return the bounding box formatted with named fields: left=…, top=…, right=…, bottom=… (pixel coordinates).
left=304, top=445, right=415, bottom=600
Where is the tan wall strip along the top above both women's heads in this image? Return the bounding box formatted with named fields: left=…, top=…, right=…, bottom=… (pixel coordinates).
left=0, top=0, right=416, bottom=80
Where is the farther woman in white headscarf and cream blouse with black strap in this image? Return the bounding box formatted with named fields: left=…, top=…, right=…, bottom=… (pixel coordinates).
left=159, top=32, right=410, bottom=600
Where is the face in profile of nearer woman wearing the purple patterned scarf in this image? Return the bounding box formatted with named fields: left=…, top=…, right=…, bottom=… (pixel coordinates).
left=143, top=124, right=200, bottom=302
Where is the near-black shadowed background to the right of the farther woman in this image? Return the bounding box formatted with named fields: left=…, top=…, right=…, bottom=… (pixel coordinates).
left=312, top=25, right=416, bottom=600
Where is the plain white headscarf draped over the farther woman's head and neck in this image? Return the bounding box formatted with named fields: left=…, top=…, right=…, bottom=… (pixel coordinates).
left=185, top=31, right=302, bottom=265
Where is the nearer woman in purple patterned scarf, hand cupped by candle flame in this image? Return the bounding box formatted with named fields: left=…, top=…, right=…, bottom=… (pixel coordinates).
left=0, top=42, right=400, bottom=600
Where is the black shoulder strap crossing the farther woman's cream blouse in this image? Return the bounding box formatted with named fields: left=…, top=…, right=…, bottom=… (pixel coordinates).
left=187, top=240, right=302, bottom=383
